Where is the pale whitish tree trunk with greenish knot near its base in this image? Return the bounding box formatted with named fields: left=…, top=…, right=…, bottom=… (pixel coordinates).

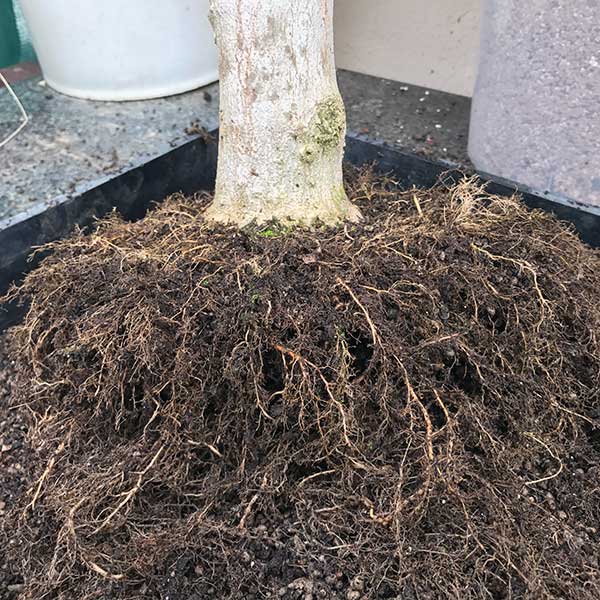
left=207, top=0, right=359, bottom=225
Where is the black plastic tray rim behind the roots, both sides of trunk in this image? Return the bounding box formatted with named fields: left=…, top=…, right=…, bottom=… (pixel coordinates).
left=0, top=131, right=600, bottom=332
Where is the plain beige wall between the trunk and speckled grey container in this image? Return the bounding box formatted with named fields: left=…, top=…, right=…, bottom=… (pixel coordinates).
left=335, top=0, right=480, bottom=96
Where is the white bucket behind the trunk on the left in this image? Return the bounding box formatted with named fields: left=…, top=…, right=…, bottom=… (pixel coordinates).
left=21, top=0, right=218, bottom=100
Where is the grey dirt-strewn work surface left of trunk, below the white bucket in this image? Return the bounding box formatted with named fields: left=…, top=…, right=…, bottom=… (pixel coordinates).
left=0, top=77, right=218, bottom=220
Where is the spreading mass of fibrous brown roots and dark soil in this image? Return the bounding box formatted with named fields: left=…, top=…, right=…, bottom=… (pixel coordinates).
left=0, top=171, right=600, bottom=600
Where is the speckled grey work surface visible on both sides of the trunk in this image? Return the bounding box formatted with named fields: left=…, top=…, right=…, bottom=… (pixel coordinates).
left=0, top=71, right=470, bottom=220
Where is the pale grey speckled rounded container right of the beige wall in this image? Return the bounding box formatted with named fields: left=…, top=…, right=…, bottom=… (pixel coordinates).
left=470, top=0, right=600, bottom=207
